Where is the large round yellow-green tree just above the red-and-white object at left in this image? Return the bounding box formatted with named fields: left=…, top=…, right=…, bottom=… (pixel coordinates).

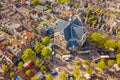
left=22, top=48, right=36, bottom=62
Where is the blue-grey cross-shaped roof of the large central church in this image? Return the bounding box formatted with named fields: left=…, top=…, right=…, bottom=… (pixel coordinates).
left=55, top=19, right=86, bottom=47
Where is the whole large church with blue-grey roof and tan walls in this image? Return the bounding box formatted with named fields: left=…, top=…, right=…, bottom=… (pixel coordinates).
left=54, top=19, right=86, bottom=50
